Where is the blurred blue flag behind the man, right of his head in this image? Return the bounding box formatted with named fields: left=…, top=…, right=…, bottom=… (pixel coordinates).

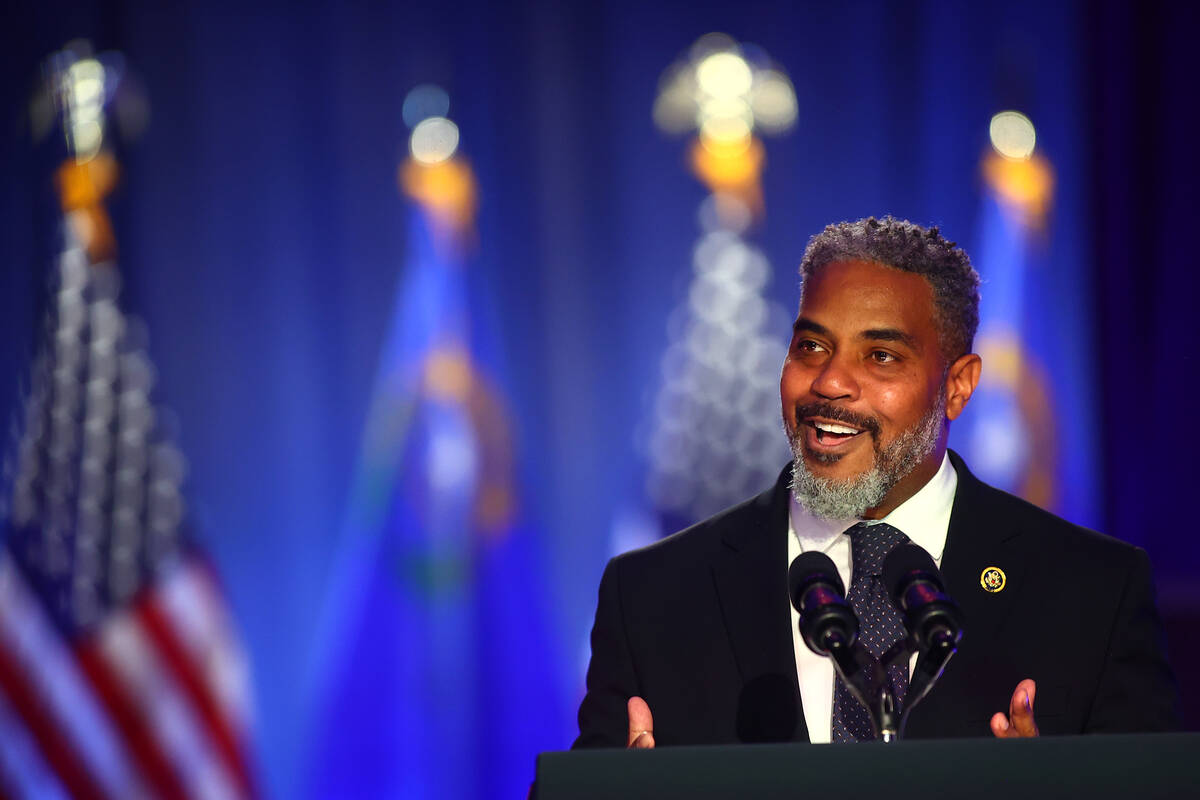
left=952, top=148, right=1096, bottom=524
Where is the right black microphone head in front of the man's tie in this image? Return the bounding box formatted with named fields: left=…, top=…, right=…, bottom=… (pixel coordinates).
left=883, top=543, right=962, bottom=652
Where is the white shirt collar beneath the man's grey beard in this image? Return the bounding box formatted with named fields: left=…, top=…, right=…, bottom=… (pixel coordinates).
left=788, top=455, right=959, bottom=561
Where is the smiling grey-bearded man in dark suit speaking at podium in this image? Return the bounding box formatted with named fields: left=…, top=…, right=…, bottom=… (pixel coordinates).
left=575, top=217, right=1178, bottom=747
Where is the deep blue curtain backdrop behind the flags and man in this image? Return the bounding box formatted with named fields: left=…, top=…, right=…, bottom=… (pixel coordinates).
left=0, top=0, right=1200, bottom=798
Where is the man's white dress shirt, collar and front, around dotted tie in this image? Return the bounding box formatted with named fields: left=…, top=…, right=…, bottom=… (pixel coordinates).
left=784, top=456, right=959, bottom=742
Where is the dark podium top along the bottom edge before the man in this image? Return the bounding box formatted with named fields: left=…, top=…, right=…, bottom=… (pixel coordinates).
left=533, top=733, right=1200, bottom=800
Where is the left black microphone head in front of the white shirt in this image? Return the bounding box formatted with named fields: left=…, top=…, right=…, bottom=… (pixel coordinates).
left=787, top=552, right=858, bottom=660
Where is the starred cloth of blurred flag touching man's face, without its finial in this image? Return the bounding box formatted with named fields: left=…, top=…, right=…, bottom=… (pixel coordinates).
left=646, top=225, right=791, bottom=518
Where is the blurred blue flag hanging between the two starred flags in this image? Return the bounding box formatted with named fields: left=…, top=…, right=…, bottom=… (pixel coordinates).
left=306, top=153, right=565, bottom=798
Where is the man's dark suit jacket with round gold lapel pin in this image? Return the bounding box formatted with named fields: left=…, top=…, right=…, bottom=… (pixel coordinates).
left=575, top=452, right=1180, bottom=747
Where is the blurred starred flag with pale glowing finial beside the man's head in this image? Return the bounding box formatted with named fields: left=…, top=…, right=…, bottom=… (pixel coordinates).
left=643, top=34, right=797, bottom=519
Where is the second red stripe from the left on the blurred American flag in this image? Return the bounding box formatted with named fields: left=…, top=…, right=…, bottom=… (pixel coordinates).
left=76, top=636, right=188, bottom=800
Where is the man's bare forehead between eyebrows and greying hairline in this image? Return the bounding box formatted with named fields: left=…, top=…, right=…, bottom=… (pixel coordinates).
left=800, top=261, right=937, bottom=339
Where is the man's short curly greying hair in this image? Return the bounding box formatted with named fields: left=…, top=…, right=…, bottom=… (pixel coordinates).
left=800, top=216, right=979, bottom=361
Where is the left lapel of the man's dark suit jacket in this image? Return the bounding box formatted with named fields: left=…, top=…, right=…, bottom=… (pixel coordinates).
left=713, top=468, right=808, bottom=741
